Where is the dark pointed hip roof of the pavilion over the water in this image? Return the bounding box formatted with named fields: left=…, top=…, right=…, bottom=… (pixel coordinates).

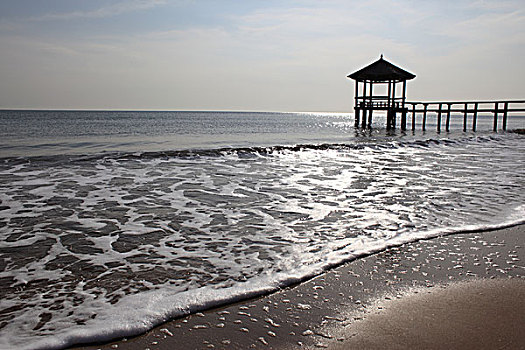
left=347, top=55, right=416, bottom=82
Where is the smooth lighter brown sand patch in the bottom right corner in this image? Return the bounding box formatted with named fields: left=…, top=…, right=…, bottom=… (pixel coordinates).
left=333, top=278, right=525, bottom=350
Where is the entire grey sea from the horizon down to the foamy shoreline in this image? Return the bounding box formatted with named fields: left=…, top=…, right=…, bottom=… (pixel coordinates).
left=0, top=111, right=525, bottom=349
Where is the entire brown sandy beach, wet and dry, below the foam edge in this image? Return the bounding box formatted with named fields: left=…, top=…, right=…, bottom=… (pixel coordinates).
left=74, top=225, right=525, bottom=350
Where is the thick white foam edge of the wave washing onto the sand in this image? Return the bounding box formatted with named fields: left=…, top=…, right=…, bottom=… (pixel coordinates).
left=21, top=211, right=525, bottom=349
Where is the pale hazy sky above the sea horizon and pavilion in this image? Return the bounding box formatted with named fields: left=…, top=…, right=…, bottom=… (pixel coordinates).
left=0, top=0, right=525, bottom=112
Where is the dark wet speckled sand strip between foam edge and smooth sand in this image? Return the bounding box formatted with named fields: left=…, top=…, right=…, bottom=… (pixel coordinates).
left=72, top=224, right=525, bottom=350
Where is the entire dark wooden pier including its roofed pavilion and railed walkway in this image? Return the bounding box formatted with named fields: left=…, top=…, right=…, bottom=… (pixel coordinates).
left=347, top=55, right=525, bottom=132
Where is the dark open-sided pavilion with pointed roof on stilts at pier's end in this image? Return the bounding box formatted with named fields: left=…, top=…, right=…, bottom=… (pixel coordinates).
left=347, top=55, right=416, bottom=130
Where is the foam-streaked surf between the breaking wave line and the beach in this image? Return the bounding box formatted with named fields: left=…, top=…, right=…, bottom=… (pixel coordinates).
left=0, top=124, right=525, bottom=348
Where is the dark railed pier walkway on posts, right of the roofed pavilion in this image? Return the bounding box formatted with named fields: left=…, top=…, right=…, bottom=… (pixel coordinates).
left=401, top=100, right=525, bottom=132
